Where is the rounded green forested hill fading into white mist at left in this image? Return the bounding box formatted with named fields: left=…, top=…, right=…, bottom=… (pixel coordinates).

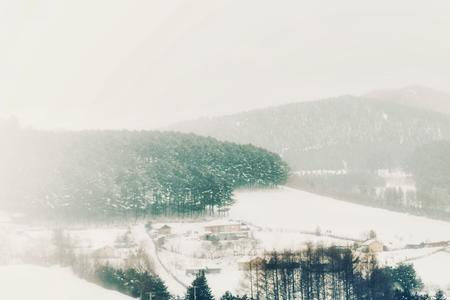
left=0, top=127, right=287, bottom=218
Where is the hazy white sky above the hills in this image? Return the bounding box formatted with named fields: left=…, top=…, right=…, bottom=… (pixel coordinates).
left=0, top=0, right=450, bottom=129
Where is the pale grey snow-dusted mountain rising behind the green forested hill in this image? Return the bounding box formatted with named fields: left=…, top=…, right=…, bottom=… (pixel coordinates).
left=170, top=92, right=450, bottom=171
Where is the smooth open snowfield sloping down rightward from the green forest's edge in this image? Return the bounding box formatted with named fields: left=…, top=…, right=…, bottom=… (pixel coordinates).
left=230, top=187, right=450, bottom=248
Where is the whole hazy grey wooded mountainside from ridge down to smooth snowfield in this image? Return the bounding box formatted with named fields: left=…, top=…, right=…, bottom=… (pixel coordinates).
left=171, top=91, right=450, bottom=218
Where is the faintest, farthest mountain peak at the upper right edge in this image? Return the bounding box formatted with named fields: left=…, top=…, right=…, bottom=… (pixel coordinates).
left=365, top=85, right=450, bottom=114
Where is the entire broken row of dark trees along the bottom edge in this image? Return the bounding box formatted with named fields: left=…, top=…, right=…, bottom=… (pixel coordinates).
left=95, top=255, right=447, bottom=300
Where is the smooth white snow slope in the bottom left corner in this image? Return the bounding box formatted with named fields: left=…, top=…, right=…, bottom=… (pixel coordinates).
left=0, top=265, right=133, bottom=300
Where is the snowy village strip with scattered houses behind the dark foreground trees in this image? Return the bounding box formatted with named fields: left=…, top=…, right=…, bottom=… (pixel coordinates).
left=142, top=218, right=450, bottom=293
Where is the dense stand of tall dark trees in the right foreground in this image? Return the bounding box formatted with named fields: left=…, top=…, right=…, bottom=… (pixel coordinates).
left=241, top=245, right=438, bottom=300
